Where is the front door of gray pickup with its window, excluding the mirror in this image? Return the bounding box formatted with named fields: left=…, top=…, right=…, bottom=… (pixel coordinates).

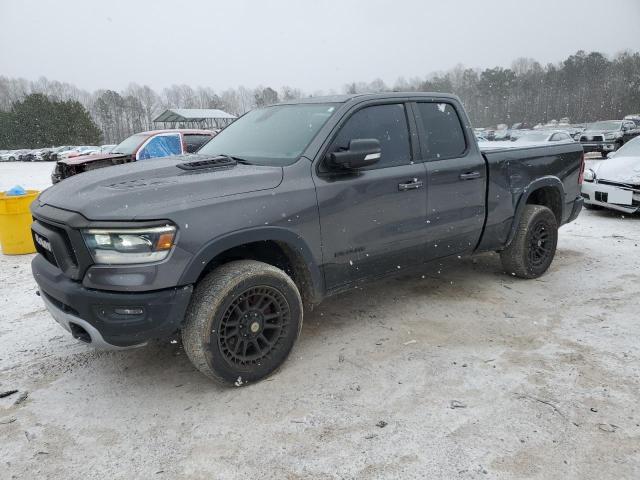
left=314, top=103, right=426, bottom=289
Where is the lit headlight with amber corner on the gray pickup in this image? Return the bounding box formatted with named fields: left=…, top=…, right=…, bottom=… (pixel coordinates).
left=82, top=225, right=176, bottom=265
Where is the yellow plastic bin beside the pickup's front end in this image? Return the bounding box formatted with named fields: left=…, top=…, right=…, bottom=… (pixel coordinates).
left=0, top=190, right=40, bottom=255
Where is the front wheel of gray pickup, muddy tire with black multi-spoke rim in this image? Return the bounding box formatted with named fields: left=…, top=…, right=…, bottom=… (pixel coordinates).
left=182, top=260, right=303, bottom=386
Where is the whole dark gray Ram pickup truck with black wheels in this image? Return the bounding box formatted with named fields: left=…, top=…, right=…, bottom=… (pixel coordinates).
left=32, top=93, right=584, bottom=385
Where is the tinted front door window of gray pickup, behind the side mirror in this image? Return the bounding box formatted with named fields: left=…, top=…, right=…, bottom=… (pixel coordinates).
left=329, top=104, right=411, bottom=169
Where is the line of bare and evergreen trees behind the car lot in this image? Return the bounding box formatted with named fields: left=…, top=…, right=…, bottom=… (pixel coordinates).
left=0, top=51, right=640, bottom=148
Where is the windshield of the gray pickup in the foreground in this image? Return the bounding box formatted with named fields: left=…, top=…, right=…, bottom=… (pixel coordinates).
left=200, top=103, right=335, bottom=166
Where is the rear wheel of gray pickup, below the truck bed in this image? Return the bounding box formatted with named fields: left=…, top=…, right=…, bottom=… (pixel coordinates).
left=500, top=205, right=558, bottom=278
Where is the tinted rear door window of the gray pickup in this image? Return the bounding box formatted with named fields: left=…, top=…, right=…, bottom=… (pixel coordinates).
left=417, top=102, right=467, bottom=160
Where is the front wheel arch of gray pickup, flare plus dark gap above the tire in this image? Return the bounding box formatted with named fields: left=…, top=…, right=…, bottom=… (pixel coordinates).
left=180, top=227, right=324, bottom=306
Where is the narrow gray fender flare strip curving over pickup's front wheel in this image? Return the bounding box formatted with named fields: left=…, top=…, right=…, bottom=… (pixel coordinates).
left=180, top=226, right=324, bottom=303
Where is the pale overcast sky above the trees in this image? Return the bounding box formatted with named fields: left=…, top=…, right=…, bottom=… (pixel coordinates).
left=0, top=0, right=640, bottom=93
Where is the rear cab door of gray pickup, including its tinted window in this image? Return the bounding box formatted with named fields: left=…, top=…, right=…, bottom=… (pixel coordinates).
left=412, top=100, right=487, bottom=260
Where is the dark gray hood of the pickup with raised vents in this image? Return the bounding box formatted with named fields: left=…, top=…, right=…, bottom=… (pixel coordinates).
left=37, top=155, right=282, bottom=220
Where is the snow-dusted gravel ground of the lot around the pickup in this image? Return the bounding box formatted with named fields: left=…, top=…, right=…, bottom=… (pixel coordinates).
left=0, top=163, right=640, bottom=480
